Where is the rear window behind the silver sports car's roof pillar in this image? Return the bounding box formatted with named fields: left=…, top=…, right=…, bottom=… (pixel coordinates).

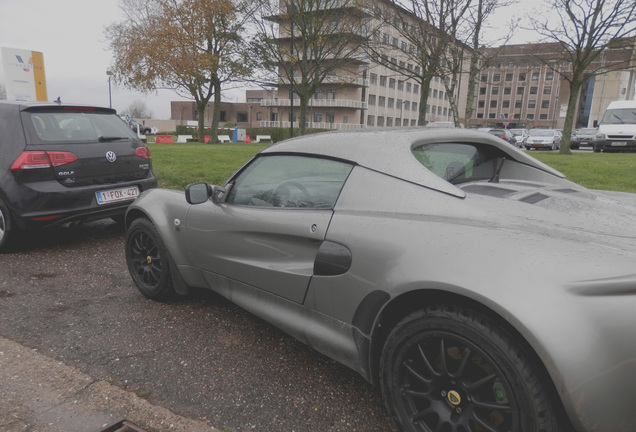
left=413, top=144, right=505, bottom=184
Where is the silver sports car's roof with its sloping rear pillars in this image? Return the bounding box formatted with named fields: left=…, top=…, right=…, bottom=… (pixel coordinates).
left=262, top=128, right=565, bottom=197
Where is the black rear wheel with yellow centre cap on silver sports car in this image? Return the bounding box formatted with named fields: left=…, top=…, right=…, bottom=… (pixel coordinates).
left=380, top=306, right=560, bottom=432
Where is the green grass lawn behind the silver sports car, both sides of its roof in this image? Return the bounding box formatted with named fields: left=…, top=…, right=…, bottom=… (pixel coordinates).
left=148, top=143, right=636, bottom=193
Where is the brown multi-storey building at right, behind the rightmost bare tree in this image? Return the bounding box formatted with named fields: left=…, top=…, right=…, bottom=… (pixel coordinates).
left=471, top=43, right=635, bottom=129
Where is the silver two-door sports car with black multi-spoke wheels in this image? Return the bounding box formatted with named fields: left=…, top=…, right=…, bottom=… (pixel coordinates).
left=126, top=129, right=636, bottom=432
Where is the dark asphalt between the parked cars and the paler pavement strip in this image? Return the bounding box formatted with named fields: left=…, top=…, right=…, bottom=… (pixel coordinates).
left=0, top=221, right=395, bottom=432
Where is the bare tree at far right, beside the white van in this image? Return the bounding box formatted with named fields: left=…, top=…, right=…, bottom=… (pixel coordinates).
left=529, top=0, right=636, bottom=154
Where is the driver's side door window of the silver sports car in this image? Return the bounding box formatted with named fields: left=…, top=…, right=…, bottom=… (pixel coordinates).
left=225, top=155, right=353, bottom=209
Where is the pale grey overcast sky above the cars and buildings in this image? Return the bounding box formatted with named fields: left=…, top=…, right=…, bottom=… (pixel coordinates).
left=0, top=0, right=541, bottom=119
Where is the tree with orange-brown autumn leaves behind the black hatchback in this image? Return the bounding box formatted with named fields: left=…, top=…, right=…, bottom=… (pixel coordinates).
left=106, top=0, right=250, bottom=142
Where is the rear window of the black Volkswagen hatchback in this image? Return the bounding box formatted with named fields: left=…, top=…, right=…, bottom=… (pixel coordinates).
left=27, top=111, right=134, bottom=143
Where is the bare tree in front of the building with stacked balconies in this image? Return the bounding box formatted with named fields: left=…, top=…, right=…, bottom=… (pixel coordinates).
left=254, top=0, right=369, bottom=134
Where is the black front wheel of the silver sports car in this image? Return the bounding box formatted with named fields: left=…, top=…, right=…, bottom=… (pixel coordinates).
left=126, top=218, right=176, bottom=301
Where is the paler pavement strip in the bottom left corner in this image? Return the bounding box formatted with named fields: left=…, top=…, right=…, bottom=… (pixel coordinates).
left=0, top=337, right=219, bottom=432
